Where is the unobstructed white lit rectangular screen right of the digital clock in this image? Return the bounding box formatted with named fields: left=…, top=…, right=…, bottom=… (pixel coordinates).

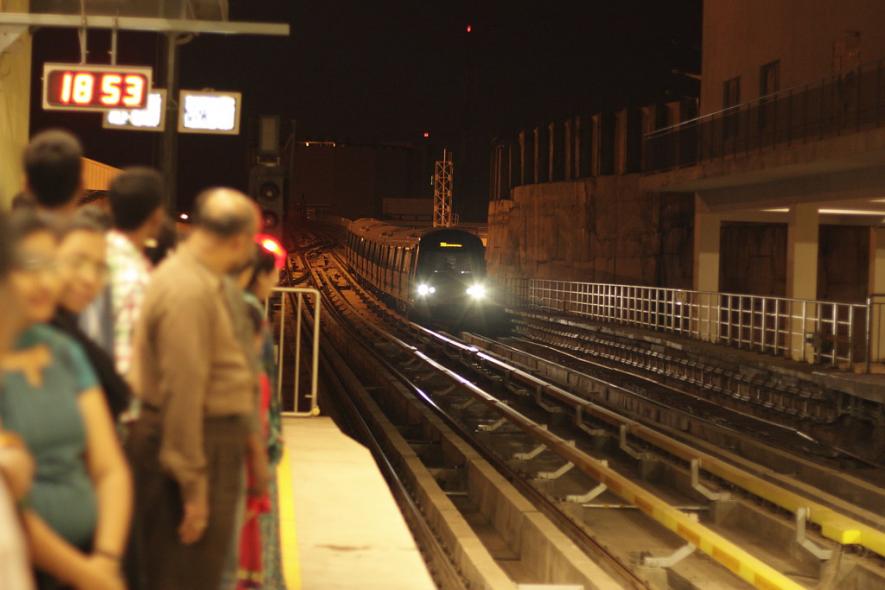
left=178, top=90, right=242, bottom=135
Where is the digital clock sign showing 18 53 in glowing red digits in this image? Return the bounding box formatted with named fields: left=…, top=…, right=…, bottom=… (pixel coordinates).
left=43, top=63, right=153, bottom=111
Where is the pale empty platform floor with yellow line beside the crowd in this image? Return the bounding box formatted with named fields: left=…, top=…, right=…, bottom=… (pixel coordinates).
left=278, top=417, right=435, bottom=590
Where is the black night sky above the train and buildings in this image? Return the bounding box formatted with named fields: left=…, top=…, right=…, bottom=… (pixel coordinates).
left=31, top=0, right=701, bottom=219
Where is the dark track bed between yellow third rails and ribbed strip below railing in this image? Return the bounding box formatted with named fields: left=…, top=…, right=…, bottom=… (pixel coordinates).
left=456, top=335, right=885, bottom=530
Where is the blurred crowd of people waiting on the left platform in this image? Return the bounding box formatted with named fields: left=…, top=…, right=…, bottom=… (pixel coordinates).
left=0, top=130, right=285, bottom=590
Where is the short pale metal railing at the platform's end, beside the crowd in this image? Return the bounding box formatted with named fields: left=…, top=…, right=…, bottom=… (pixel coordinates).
left=265, top=287, right=321, bottom=416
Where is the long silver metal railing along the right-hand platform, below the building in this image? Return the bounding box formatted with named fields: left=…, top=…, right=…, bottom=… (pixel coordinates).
left=507, top=278, right=885, bottom=371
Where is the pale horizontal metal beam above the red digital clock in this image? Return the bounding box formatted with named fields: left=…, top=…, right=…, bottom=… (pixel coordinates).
left=0, top=12, right=289, bottom=37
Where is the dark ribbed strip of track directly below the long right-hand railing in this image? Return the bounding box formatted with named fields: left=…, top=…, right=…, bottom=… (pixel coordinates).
left=511, top=308, right=885, bottom=468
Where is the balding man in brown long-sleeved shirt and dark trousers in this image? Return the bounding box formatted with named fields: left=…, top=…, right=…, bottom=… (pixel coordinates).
left=128, top=189, right=266, bottom=590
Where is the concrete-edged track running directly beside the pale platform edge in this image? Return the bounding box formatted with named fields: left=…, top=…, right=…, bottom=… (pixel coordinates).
left=290, top=246, right=628, bottom=589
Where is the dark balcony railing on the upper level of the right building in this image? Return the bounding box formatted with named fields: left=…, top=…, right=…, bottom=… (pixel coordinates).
left=642, top=61, right=885, bottom=173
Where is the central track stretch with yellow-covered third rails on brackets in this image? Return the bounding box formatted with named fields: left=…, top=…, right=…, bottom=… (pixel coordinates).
left=284, top=232, right=882, bottom=588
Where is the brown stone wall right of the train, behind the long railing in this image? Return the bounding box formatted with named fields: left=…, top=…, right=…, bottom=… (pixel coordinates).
left=487, top=174, right=694, bottom=288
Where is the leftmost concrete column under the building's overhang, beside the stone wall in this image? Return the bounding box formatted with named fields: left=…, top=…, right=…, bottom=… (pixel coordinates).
left=692, top=196, right=722, bottom=342
